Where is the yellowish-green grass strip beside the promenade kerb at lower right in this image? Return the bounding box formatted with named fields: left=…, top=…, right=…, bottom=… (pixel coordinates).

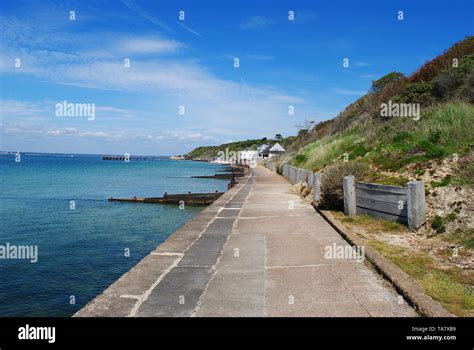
left=368, top=240, right=474, bottom=316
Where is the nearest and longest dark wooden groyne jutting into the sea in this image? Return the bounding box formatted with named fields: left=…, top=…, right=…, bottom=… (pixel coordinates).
left=109, top=191, right=224, bottom=205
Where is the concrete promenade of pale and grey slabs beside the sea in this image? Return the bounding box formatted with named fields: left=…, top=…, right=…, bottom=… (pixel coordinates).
left=75, top=166, right=416, bottom=317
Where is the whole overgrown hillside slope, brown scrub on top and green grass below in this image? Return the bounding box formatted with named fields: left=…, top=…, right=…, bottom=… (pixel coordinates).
left=284, top=36, right=474, bottom=179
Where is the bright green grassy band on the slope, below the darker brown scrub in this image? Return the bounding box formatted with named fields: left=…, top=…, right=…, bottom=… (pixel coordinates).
left=293, top=102, right=474, bottom=175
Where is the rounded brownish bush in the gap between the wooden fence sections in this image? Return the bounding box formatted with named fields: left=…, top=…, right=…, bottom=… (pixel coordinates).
left=320, top=162, right=367, bottom=210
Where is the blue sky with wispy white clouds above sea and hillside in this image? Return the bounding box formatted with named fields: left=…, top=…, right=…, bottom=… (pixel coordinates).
left=0, top=0, right=474, bottom=155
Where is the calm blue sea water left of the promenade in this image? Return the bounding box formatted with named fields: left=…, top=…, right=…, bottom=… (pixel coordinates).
left=0, top=154, right=227, bottom=316
